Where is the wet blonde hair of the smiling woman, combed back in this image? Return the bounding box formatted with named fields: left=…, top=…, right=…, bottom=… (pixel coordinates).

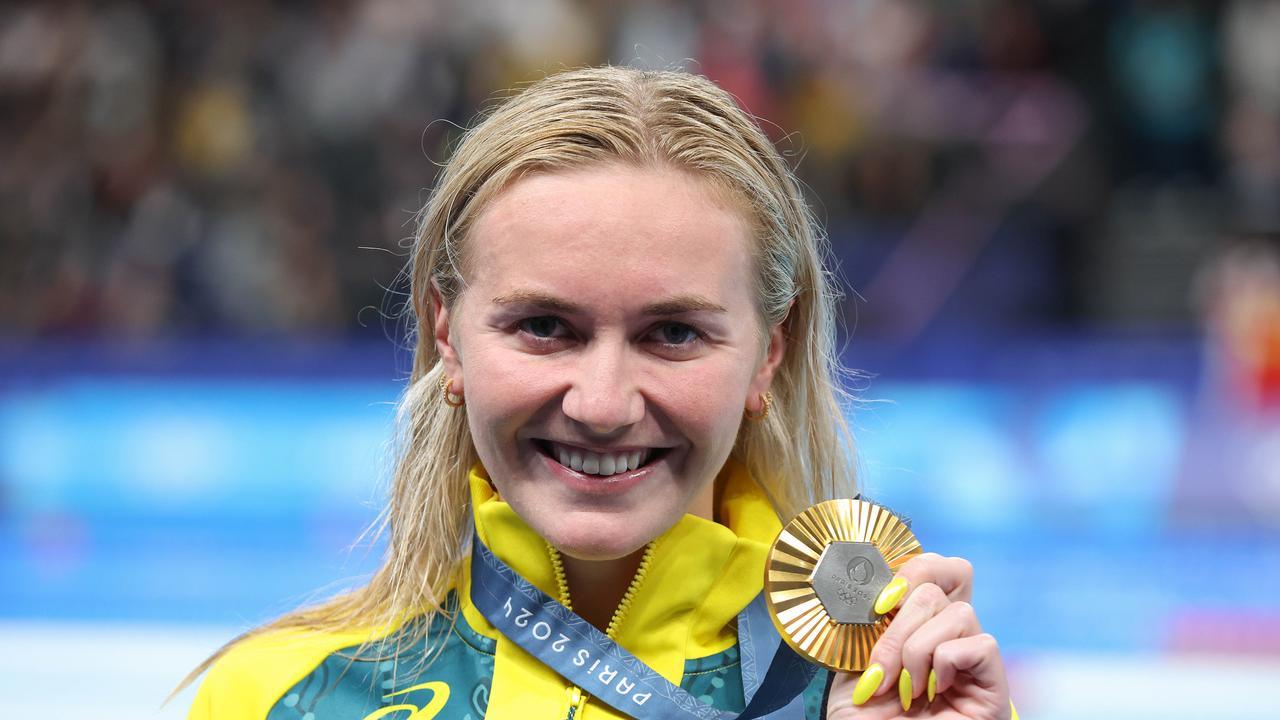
left=177, top=67, right=855, bottom=682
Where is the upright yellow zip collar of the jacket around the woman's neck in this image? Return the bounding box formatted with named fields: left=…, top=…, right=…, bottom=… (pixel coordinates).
left=458, top=460, right=782, bottom=684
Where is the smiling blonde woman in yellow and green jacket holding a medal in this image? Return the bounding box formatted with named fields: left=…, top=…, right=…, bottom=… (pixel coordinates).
left=183, top=68, right=1010, bottom=720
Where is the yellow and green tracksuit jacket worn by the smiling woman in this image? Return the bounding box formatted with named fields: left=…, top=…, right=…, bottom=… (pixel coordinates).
left=188, top=462, right=827, bottom=720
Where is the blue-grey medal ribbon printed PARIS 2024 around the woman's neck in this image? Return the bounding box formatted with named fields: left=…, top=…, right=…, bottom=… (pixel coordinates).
left=471, top=537, right=817, bottom=720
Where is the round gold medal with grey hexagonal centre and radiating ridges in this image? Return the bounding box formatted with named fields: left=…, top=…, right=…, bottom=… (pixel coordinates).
left=764, top=500, right=920, bottom=671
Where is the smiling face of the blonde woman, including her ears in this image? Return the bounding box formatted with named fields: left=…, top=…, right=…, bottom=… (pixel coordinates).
left=435, top=165, right=783, bottom=560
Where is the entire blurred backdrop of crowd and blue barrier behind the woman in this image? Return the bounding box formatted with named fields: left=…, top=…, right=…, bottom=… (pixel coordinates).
left=0, top=0, right=1280, bottom=719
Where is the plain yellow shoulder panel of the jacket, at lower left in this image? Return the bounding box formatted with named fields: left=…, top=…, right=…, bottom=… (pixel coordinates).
left=187, top=622, right=381, bottom=720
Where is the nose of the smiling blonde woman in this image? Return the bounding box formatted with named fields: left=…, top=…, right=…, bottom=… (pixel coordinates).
left=563, top=338, right=644, bottom=436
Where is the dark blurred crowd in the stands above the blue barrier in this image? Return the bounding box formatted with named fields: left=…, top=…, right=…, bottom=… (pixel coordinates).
left=0, top=0, right=1280, bottom=340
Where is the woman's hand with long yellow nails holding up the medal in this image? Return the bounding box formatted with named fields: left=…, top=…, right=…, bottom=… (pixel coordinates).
left=827, top=552, right=1011, bottom=720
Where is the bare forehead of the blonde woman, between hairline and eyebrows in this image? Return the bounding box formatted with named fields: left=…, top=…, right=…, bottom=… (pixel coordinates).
left=466, top=165, right=754, bottom=310
